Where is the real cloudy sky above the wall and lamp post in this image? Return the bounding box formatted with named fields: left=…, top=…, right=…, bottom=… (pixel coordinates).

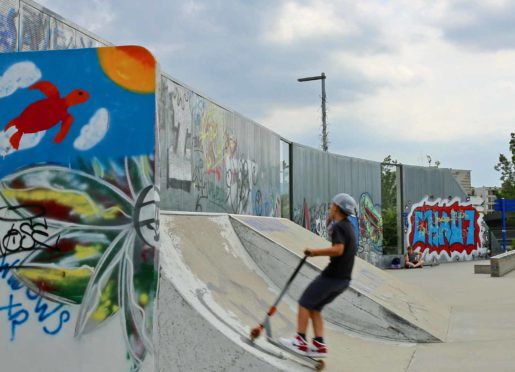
left=39, top=0, right=515, bottom=186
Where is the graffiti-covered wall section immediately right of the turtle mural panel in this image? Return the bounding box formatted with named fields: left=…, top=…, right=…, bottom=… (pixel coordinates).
left=159, top=77, right=281, bottom=216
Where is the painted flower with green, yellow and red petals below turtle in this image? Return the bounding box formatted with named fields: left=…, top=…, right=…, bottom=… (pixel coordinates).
left=0, top=156, right=159, bottom=370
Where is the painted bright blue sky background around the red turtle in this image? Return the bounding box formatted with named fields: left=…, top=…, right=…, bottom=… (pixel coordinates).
left=0, top=49, right=155, bottom=178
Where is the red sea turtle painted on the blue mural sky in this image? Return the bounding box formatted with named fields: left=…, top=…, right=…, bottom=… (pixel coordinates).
left=4, top=81, right=89, bottom=149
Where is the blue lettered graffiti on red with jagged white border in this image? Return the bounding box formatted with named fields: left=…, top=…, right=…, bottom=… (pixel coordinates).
left=407, top=197, right=486, bottom=261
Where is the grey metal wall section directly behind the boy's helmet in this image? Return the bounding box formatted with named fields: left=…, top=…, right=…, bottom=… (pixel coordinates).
left=292, top=144, right=383, bottom=264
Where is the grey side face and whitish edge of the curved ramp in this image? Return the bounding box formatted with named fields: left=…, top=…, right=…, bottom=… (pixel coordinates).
left=157, top=216, right=309, bottom=372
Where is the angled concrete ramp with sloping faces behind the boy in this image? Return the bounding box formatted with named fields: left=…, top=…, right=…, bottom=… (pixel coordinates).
left=231, top=215, right=450, bottom=342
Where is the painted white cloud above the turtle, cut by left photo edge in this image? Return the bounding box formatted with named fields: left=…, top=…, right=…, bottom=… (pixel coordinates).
left=0, top=62, right=41, bottom=98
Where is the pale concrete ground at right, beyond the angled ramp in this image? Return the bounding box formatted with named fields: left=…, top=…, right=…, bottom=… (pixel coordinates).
left=387, top=261, right=515, bottom=371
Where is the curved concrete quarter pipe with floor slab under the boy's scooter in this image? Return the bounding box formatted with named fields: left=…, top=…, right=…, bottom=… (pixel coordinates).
left=158, top=214, right=415, bottom=372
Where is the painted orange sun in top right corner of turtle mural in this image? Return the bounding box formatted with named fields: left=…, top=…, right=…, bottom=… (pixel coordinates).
left=97, top=45, right=156, bottom=93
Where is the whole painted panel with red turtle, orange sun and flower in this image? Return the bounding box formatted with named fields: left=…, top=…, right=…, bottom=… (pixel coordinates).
left=0, top=46, right=159, bottom=371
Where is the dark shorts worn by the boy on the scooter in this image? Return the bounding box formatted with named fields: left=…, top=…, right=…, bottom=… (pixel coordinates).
left=299, top=275, right=350, bottom=311
